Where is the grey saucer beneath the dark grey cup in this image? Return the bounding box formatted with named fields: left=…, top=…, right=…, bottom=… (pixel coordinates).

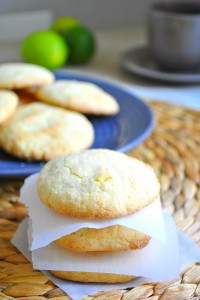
left=121, top=46, right=200, bottom=83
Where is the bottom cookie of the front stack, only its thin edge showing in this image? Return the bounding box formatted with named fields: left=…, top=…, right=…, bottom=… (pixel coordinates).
left=50, top=270, right=136, bottom=283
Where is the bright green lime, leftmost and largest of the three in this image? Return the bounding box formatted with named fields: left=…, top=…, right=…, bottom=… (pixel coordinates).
left=21, top=30, right=68, bottom=70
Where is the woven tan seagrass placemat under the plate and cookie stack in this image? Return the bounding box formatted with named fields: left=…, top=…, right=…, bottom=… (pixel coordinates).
left=0, top=102, right=200, bottom=300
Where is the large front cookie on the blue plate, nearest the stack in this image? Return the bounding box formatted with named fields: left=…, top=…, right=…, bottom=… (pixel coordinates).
left=0, top=103, right=94, bottom=161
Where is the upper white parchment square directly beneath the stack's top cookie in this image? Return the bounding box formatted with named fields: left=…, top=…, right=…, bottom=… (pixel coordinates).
left=20, top=174, right=166, bottom=250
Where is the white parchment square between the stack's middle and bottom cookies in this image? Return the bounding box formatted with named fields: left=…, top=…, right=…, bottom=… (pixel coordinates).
left=32, top=215, right=179, bottom=280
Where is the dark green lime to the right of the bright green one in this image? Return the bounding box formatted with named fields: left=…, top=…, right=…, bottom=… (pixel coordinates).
left=63, top=26, right=95, bottom=64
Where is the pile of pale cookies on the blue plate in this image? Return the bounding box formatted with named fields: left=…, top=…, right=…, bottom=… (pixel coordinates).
left=0, top=63, right=119, bottom=161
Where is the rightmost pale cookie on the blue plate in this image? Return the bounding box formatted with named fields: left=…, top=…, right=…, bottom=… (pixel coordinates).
left=36, top=80, right=119, bottom=115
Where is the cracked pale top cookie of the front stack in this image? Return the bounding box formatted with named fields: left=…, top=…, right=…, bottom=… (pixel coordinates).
left=38, top=149, right=160, bottom=219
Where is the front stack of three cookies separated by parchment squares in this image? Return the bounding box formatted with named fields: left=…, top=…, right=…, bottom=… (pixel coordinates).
left=32, top=149, right=160, bottom=283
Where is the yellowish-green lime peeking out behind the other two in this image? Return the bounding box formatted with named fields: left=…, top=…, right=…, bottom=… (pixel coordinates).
left=51, top=17, right=79, bottom=35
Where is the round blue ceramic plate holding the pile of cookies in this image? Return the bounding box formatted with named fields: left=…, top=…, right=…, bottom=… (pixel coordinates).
left=0, top=72, right=153, bottom=178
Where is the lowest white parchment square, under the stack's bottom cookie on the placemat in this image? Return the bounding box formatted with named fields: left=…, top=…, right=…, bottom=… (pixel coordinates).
left=12, top=215, right=200, bottom=300
